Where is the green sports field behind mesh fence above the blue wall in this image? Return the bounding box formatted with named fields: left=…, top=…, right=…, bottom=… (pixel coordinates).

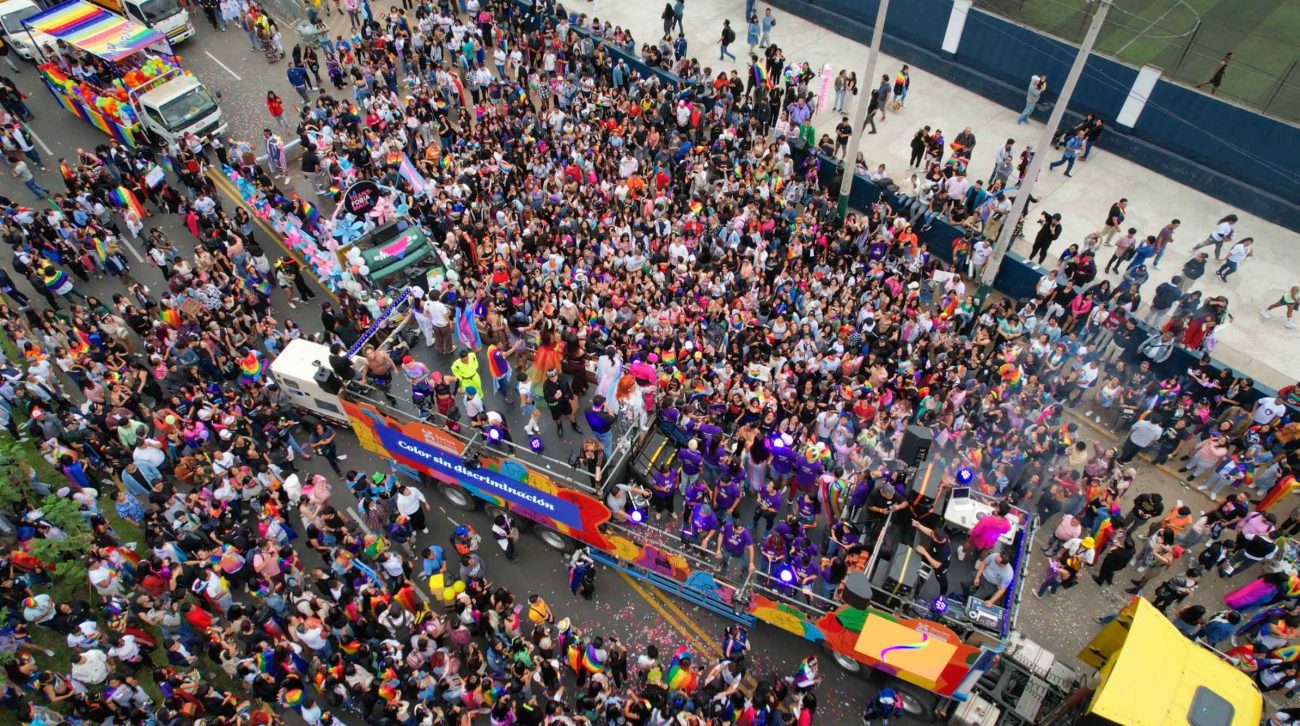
left=974, top=0, right=1300, bottom=121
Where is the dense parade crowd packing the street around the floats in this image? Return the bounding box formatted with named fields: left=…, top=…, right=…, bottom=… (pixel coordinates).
left=0, top=0, right=1300, bottom=726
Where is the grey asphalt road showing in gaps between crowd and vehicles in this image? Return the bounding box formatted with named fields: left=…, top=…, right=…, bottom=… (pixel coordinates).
left=0, top=14, right=1289, bottom=725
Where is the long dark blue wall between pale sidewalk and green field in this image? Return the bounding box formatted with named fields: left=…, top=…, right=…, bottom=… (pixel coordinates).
left=768, top=0, right=1300, bottom=229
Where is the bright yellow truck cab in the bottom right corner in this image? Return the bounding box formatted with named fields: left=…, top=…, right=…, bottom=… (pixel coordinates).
left=1079, top=597, right=1264, bottom=726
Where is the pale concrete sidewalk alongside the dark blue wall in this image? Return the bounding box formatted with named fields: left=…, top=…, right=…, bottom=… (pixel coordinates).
left=585, top=0, right=1300, bottom=388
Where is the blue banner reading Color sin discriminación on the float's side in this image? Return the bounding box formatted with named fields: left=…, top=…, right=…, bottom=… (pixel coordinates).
left=374, top=422, right=582, bottom=530
